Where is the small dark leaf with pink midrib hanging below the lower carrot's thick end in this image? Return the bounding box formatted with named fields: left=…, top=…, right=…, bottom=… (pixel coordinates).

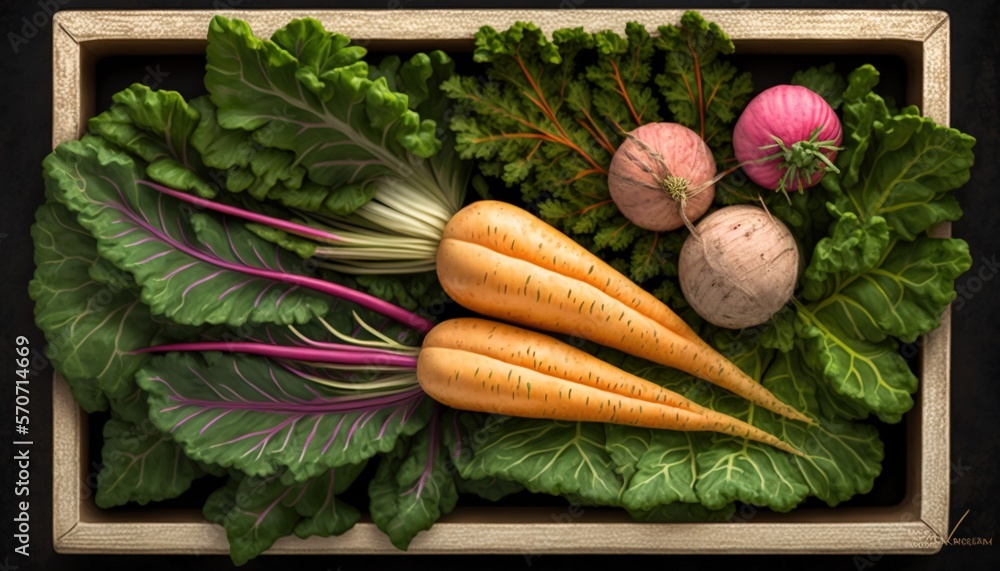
left=368, top=411, right=458, bottom=550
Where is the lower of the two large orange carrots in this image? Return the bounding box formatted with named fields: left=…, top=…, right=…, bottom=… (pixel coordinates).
left=417, top=318, right=801, bottom=455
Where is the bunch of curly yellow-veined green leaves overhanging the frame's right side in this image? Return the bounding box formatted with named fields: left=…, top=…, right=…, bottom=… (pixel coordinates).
left=794, top=66, right=975, bottom=422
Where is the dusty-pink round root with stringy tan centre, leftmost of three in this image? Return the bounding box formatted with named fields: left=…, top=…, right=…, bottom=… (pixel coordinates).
left=608, top=123, right=715, bottom=231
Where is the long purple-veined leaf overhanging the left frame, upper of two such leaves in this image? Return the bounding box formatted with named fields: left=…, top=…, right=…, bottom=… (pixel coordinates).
left=44, top=137, right=338, bottom=326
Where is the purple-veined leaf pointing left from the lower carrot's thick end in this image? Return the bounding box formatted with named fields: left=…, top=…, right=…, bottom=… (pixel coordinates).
left=136, top=353, right=433, bottom=482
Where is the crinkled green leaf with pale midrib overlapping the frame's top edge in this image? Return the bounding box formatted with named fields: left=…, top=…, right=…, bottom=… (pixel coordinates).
left=205, top=16, right=441, bottom=190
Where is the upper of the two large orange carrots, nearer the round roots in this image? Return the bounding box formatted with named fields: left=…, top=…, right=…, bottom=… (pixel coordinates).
left=437, top=200, right=812, bottom=423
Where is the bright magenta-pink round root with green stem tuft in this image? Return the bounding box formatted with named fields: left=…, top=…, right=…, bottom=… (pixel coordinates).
left=733, top=85, right=842, bottom=192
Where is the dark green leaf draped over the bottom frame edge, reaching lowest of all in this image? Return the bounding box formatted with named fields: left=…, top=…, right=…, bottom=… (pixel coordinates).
left=202, top=463, right=364, bottom=565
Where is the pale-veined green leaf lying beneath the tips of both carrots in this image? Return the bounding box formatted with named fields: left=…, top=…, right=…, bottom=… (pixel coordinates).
left=600, top=332, right=882, bottom=521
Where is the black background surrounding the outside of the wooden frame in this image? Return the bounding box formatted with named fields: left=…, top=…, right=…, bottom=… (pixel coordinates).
left=0, top=0, right=1000, bottom=571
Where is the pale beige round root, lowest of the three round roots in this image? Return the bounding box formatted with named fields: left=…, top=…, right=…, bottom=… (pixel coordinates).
left=678, top=205, right=799, bottom=329
